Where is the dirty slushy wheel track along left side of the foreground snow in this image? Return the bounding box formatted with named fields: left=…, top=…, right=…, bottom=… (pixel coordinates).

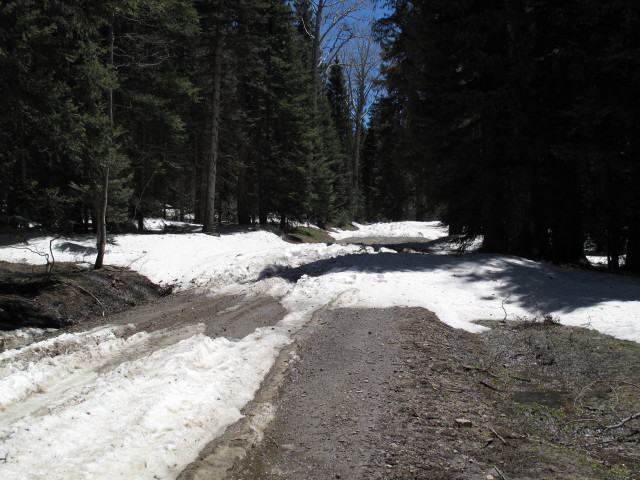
left=0, top=295, right=286, bottom=479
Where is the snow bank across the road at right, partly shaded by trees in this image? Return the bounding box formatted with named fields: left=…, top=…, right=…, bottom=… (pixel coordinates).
left=238, top=253, right=640, bottom=342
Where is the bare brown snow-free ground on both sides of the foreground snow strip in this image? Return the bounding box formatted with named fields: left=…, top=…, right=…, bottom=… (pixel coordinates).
left=0, top=253, right=640, bottom=480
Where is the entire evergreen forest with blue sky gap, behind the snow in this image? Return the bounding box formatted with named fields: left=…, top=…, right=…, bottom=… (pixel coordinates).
left=0, top=0, right=640, bottom=273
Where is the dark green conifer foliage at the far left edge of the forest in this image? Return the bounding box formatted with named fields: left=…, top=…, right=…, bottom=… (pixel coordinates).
left=0, top=0, right=129, bottom=231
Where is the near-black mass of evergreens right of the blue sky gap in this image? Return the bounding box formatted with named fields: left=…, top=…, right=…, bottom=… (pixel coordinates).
left=368, top=0, right=640, bottom=271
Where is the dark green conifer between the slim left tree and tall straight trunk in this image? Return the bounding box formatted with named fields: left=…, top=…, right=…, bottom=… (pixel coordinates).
left=116, top=1, right=200, bottom=230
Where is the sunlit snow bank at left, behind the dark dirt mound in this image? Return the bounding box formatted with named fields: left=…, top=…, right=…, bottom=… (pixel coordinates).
left=0, top=231, right=358, bottom=291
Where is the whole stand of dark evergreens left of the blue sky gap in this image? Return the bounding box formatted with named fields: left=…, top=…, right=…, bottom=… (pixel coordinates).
left=0, top=0, right=358, bottom=255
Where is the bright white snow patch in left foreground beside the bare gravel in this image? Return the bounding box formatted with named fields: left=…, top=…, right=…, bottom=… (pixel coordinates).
left=0, top=329, right=289, bottom=479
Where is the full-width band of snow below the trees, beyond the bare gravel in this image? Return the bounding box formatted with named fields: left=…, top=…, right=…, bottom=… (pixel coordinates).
left=0, top=222, right=640, bottom=341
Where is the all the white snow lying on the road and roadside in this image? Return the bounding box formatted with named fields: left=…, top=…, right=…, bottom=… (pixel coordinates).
left=0, top=222, right=640, bottom=479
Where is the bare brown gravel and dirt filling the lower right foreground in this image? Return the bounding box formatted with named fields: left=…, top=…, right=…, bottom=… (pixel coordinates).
left=219, top=309, right=640, bottom=480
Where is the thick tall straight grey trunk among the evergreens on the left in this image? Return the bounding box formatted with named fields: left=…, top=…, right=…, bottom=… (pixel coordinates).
left=202, top=0, right=224, bottom=233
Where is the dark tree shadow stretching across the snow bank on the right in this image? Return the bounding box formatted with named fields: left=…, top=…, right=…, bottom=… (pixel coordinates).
left=258, top=253, right=640, bottom=313
